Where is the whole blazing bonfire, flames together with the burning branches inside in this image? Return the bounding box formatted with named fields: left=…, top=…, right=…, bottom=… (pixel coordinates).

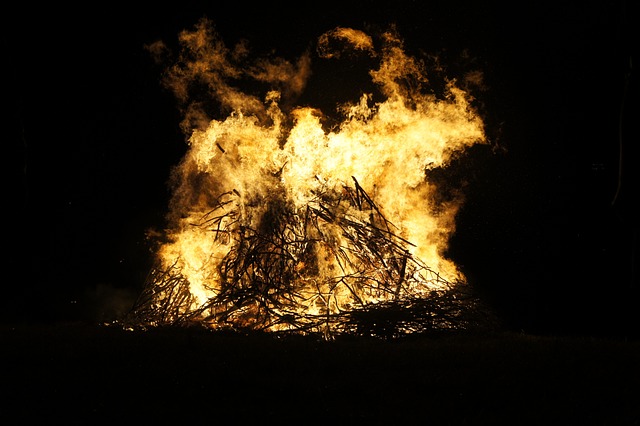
left=130, top=20, right=486, bottom=333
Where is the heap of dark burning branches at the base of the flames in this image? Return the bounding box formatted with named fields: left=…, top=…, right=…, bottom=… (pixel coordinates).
left=126, top=178, right=496, bottom=338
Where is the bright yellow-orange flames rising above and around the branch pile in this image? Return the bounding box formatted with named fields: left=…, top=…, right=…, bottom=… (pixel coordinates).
left=148, top=21, right=485, bottom=332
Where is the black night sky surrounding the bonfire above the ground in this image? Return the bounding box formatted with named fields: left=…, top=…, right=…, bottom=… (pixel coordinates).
left=1, top=0, right=639, bottom=333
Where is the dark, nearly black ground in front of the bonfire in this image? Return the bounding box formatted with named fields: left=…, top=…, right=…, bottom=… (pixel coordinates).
left=0, top=323, right=640, bottom=425
